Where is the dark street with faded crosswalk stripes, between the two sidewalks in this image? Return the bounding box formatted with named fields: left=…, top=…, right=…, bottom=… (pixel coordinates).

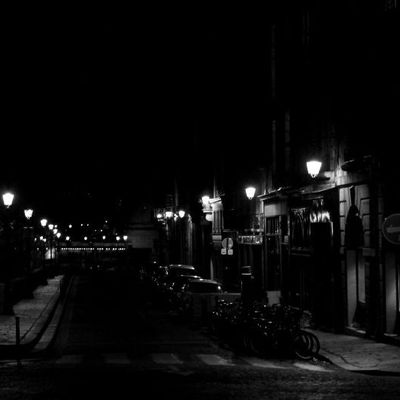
left=0, top=272, right=400, bottom=400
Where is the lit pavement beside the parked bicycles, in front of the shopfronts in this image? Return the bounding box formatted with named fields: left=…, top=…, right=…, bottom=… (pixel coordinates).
left=307, top=329, right=400, bottom=376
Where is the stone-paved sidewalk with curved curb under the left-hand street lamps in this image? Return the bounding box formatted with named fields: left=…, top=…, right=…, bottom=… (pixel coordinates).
left=0, top=275, right=67, bottom=359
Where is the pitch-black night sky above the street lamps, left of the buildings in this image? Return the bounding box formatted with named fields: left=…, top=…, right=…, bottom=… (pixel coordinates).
left=0, top=7, right=265, bottom=220
